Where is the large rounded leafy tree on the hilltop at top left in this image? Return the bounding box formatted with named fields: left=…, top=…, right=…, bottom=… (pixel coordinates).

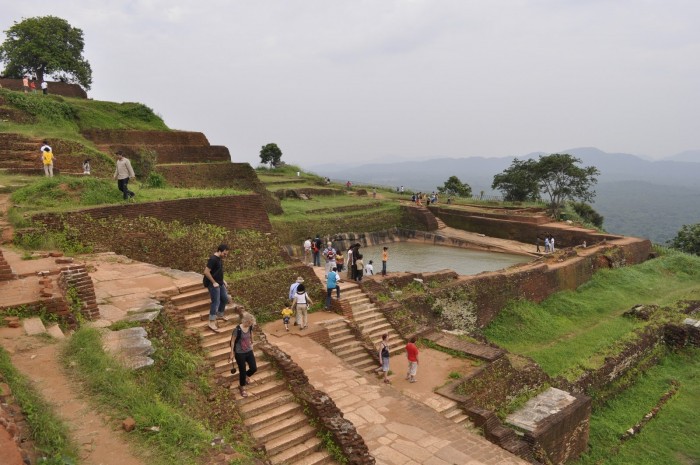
left=0, top=16, right=92, bottom=90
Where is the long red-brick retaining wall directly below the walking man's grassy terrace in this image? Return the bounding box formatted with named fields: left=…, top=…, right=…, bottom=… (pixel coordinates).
left=32, top=194, right=272, bottom=234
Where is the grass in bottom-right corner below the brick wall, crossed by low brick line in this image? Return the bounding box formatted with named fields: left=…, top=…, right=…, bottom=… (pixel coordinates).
left=577, top=348, right=700, bottom=465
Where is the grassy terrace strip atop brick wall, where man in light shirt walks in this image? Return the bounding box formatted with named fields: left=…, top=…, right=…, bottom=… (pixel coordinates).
left=11, top=176, right=250, bottom=212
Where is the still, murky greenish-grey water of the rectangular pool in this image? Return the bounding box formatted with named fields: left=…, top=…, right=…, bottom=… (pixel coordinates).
left=350, top=242, right=531, bottom=275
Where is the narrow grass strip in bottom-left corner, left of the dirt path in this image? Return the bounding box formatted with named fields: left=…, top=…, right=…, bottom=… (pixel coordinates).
left=0, top=348, right=78, bottom=465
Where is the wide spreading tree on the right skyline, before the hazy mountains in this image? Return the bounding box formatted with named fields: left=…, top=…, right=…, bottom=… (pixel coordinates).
left=492, top=153, right=600, bottom=217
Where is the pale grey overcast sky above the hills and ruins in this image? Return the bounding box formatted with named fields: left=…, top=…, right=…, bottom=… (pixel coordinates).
left=0, top=0, right=700, bottom=169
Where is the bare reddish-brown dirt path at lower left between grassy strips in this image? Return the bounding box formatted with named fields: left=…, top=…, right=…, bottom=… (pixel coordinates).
left=0, top=328, right=148, bottom=465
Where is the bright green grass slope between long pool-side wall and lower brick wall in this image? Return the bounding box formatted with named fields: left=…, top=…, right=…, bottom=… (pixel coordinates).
left=484, top=253, right=700, bottom=379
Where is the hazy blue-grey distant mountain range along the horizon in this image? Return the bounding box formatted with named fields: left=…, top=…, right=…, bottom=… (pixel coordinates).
left=312, top=147, right=700, bottom=243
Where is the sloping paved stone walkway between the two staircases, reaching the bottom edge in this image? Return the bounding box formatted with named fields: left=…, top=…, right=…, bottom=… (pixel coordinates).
left=265, top=326, right=527, bottom=465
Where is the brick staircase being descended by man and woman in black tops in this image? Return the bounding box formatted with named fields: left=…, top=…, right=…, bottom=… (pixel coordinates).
left=171, top=283, right=336, bottom=465
